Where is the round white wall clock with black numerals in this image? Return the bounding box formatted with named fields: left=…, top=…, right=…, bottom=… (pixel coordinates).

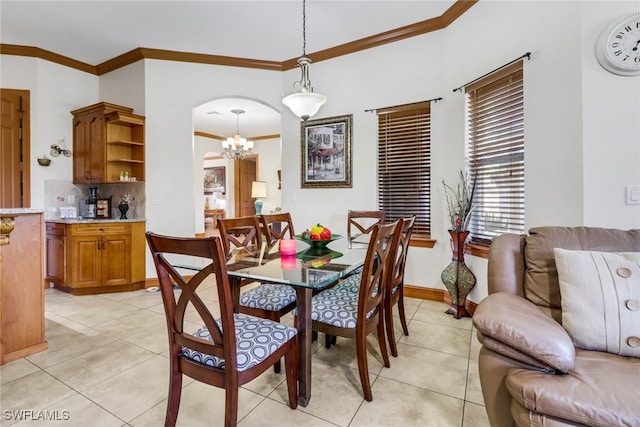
left=596, top=12, right=640, bottom=76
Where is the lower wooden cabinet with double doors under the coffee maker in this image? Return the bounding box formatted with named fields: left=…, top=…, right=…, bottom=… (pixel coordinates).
left=47, top=222, right=145, bottom=295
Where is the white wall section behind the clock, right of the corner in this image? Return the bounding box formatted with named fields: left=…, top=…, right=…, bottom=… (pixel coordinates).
left=580, top=1, right=640, bottom=229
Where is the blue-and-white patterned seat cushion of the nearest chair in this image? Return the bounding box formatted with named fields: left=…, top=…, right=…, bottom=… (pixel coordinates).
left=180, top=313, right=297, bottom=371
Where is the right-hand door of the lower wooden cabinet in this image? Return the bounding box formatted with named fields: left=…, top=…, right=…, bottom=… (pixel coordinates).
left=100, top=235, right=131, bottom=286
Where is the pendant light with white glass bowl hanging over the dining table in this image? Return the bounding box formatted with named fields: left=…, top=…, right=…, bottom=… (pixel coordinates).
left=282, top=0, right=327, bottom=121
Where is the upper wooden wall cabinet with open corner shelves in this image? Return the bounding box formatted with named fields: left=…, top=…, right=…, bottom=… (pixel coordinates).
left=71, top=102, right=144, bottom=184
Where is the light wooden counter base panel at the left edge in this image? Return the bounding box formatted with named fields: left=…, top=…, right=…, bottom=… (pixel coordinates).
left=0, top=213, right=48, bottom=365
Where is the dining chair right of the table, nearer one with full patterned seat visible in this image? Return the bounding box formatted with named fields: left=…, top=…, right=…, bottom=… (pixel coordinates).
left=304, top=220, right=401, bottom=402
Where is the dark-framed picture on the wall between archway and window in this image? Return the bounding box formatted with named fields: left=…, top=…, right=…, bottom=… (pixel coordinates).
left=300, top=114, right=353, bottom=188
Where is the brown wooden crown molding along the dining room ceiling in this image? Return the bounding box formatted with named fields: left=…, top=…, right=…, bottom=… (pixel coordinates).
left=0, top=0, right=479, bottom=76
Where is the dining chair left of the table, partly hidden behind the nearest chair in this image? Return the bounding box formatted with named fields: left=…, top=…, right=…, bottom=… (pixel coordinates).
left=218, top=216, right=296, bottom=372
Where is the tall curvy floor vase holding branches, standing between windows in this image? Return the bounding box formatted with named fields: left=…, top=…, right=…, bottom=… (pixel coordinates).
left=440, top=230, right=476, bottom=319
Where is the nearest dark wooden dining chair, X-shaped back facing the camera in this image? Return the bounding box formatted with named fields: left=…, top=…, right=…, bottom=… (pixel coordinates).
left=146, top=232, right=298, bottom=427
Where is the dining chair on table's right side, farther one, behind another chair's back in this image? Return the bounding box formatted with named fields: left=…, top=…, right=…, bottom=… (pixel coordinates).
left=384, top=216, right=416, bottom=357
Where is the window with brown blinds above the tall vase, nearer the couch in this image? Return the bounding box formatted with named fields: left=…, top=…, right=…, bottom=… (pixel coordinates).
left=465, top=61, right=524, bottom=244
